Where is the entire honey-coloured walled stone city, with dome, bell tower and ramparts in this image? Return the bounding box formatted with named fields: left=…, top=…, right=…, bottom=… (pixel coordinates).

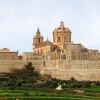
left=0, top=21, right=100, bottom=81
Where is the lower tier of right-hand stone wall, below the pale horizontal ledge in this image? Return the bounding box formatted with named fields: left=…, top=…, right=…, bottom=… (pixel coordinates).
left=45, top=69, right=100, bottom=81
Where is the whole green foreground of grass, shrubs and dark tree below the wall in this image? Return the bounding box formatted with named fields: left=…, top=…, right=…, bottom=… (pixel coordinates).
left=0, top=63, right=100, bottom=100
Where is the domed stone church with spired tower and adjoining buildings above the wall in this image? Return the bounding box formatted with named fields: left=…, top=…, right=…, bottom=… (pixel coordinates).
left=33, top=22, right=100, bottom=60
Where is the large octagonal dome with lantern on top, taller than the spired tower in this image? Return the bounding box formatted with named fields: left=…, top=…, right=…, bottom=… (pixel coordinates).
left=53, top=21, right=71, bottom=45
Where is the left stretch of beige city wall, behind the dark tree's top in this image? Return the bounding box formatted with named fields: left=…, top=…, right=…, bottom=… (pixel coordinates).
left=0, top=60, right=42, bottom=73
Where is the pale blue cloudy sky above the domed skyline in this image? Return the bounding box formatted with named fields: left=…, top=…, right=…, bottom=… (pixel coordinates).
left=0, top=0, right=100, bottom=53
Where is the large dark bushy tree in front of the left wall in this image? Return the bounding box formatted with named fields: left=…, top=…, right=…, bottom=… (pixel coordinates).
left=2, top=62, right=41, bottom=88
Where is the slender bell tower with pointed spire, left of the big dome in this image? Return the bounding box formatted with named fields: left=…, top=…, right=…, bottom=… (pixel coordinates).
left=32, top=28, right=43, bottom=49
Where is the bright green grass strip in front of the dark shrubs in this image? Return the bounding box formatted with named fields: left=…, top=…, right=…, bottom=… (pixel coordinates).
left=0, top=87, right=100, bottom=100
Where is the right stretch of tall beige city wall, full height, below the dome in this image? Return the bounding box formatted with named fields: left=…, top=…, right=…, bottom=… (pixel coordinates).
left=43, top=60, right=100, bottom=81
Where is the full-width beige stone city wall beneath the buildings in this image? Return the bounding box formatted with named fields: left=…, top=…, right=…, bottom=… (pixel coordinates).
left=0, top=60, right=100, bottom=81
